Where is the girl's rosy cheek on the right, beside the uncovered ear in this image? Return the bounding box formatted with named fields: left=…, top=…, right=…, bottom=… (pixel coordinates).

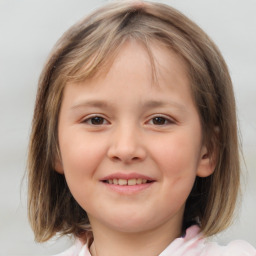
left=149, top=133, right=200, bottom=202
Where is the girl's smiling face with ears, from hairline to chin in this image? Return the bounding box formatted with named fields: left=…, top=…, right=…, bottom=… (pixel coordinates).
left=56, top=41, right=213, bottom=234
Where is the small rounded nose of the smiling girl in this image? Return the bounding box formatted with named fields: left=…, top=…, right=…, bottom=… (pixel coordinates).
left=108, top=125, right=146, bottom=164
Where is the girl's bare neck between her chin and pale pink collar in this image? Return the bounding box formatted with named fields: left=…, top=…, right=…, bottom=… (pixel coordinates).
left=90, top=218, right=181, bottom=256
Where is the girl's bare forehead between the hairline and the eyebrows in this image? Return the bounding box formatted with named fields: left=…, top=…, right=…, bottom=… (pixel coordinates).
left=65, top=41, right=195, bottom=111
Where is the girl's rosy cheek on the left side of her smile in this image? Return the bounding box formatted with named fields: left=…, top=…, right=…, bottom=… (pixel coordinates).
left=60, top=134, right=105, bottom=209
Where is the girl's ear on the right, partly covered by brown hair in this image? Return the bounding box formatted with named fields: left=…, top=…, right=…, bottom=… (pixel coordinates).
left=196, top=146, right=216, bottom=178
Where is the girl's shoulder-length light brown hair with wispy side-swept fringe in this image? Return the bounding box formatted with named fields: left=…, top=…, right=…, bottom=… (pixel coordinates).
left=28, top=1, right=240, bottom=242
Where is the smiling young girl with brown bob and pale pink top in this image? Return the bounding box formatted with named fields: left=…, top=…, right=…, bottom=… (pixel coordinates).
left=28, top=1, right=256, bottom=256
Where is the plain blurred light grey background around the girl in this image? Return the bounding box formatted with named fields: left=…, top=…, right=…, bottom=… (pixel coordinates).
left=0, top=0, right=256, bottom=255
